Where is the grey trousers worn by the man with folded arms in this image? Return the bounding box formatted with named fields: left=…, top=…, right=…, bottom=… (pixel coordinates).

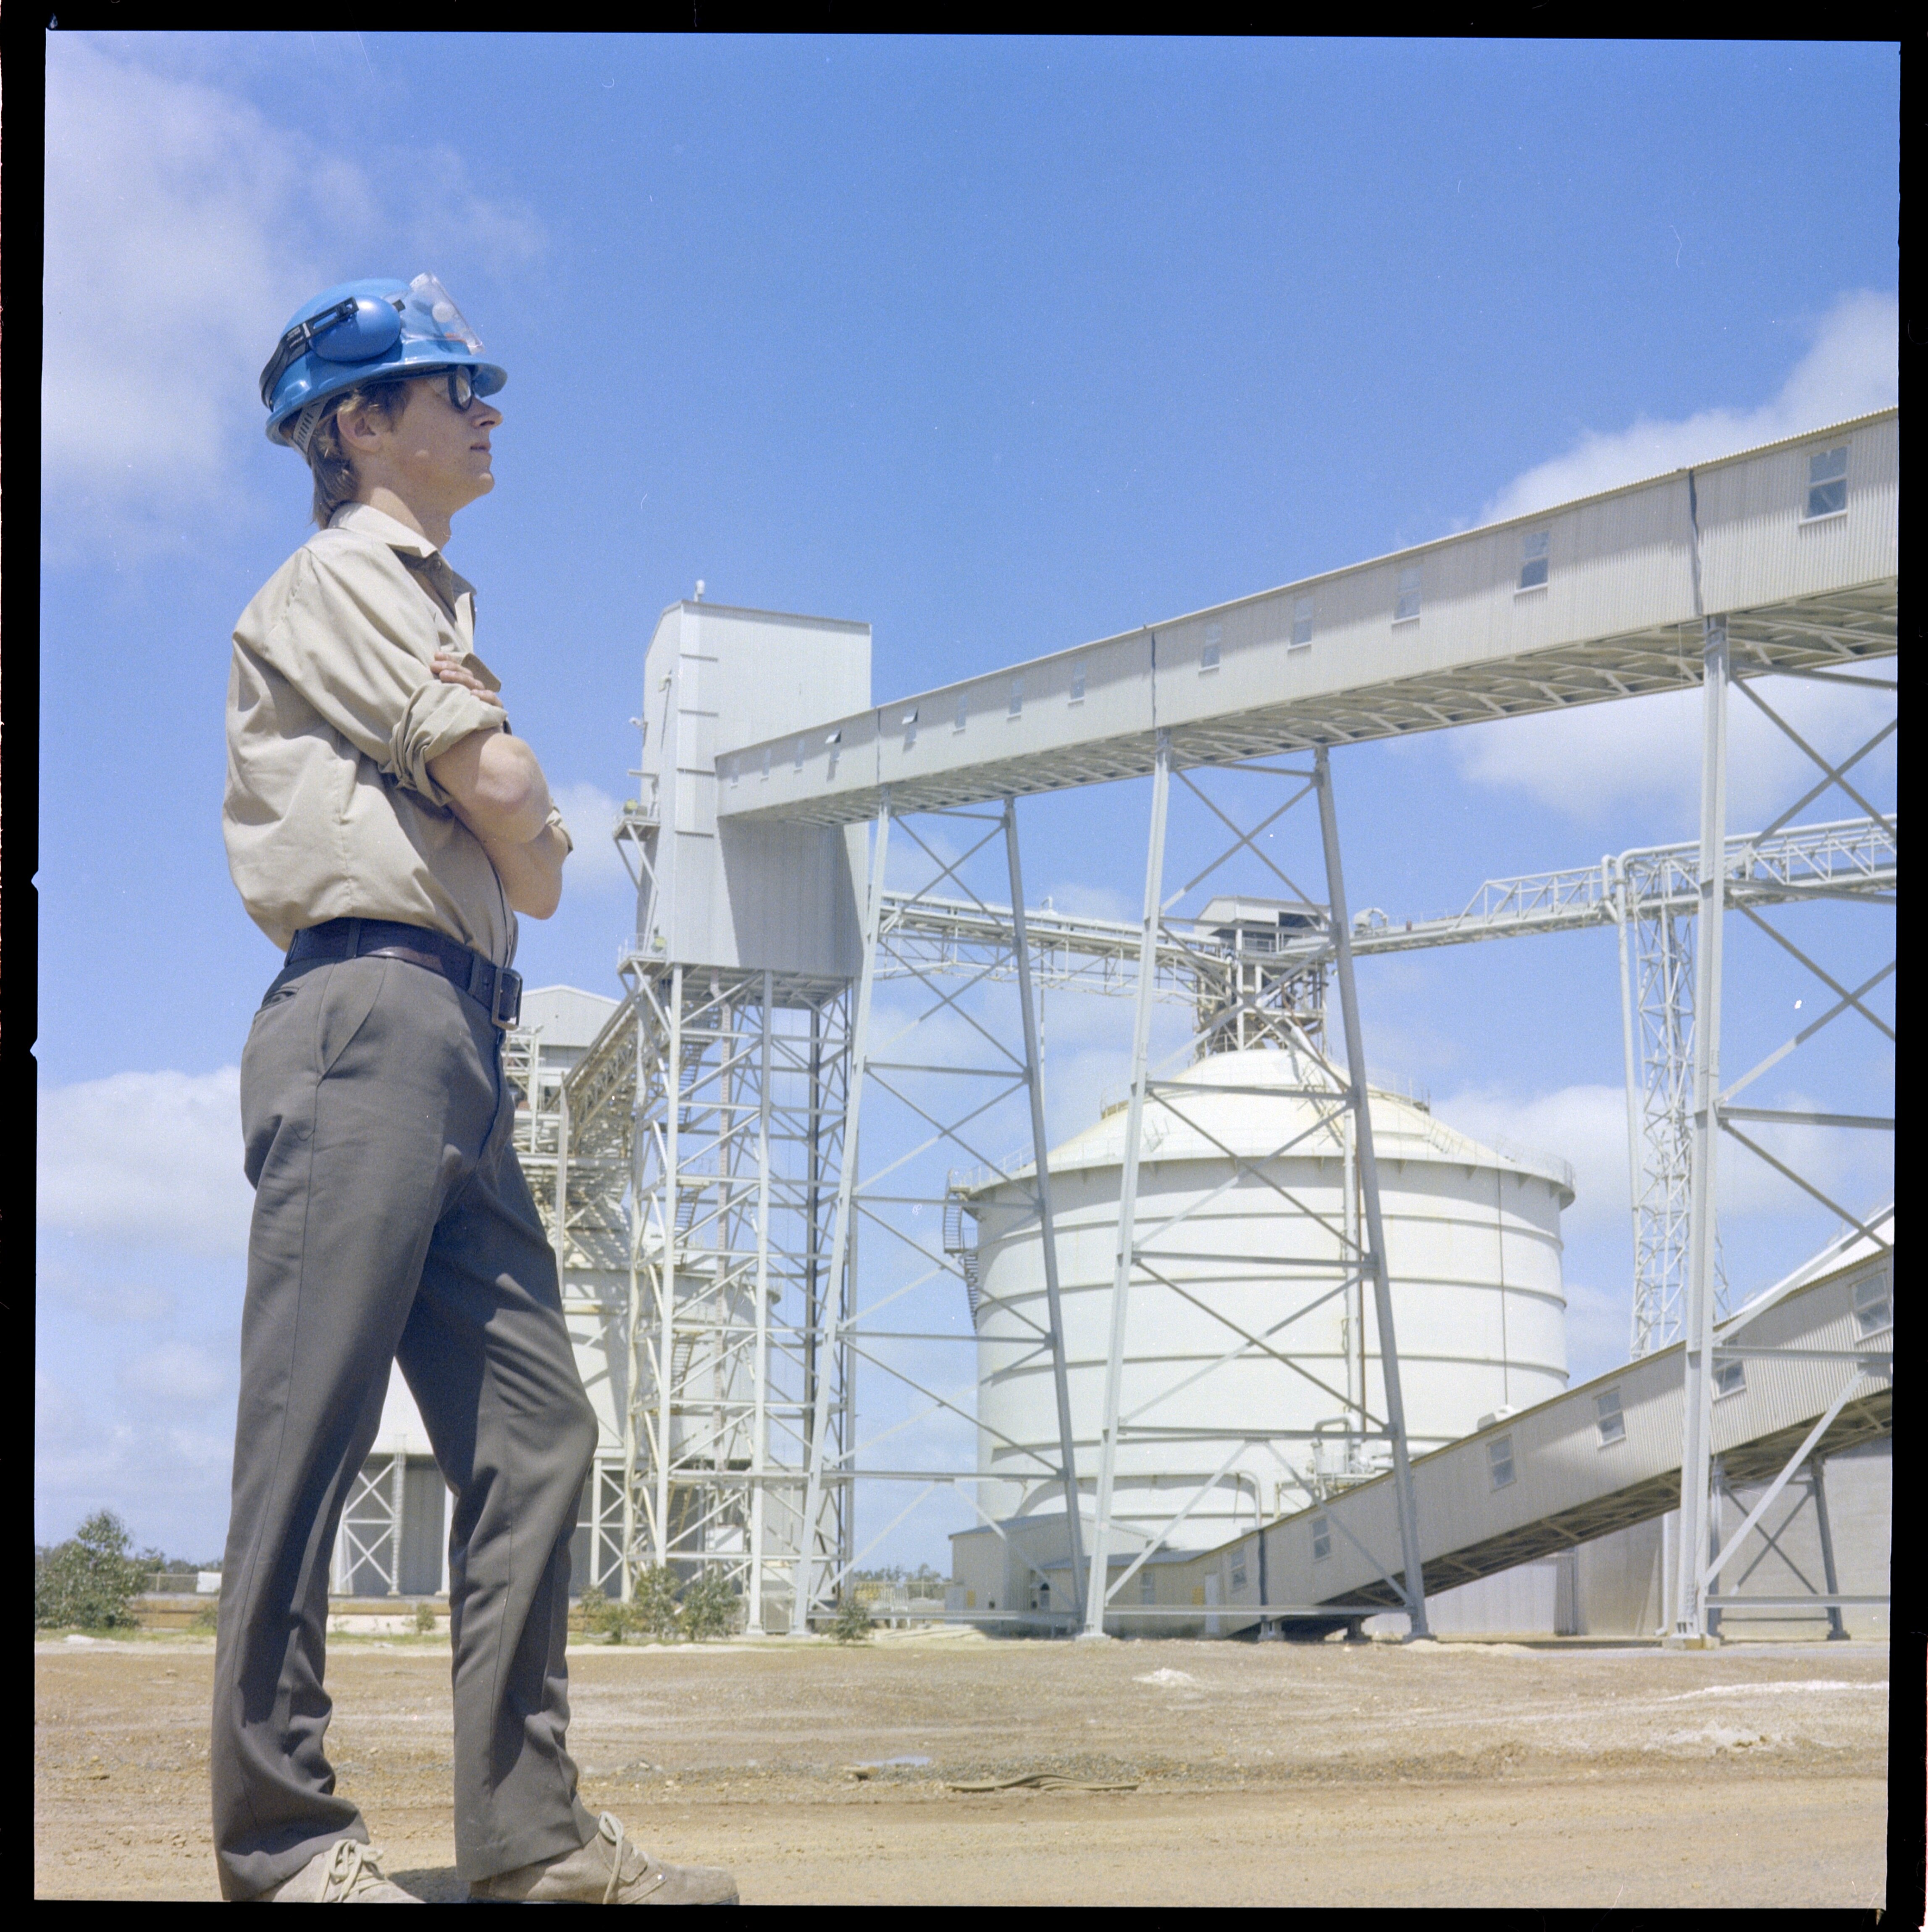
left=210, top=958, right=595, bottom=1899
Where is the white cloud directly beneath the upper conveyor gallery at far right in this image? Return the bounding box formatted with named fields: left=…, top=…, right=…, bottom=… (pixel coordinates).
left=1453, top=678, right=1895, bottom=831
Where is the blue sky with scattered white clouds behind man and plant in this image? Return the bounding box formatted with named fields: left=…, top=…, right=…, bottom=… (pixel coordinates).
left=37, top=33, right=1899, bottom=1563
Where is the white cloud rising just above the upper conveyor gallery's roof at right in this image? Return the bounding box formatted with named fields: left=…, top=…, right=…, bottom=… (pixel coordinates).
left=1480, top=290, right=1901, bottom=524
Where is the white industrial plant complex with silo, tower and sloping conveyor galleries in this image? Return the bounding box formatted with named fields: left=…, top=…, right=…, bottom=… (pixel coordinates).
left=336, top=410, right=1899, bottom=1642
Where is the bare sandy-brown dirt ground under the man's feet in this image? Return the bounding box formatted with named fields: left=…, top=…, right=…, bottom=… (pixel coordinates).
left=33, top=1633, right=1887, bottom=1909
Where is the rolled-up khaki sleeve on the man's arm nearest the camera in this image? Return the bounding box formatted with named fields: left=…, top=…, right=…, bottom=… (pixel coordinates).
left=261, top=545, right=508, bottom=806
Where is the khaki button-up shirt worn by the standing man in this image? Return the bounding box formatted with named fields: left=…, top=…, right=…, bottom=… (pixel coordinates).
left=222, top=502, right=556, bottom=966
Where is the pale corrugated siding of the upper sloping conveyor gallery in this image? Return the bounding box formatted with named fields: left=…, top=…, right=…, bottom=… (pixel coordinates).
left=725, top=412, right=1899, bottom=815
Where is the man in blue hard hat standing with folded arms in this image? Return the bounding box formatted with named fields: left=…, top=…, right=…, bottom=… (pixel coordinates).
left=213, top=276, right=736, bottom=1905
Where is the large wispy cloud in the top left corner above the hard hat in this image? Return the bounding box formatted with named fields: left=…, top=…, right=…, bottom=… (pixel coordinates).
left=42, top=33, right=541, bottom=549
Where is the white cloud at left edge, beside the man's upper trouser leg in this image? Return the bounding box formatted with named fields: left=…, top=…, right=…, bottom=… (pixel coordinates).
left=37, top=1066, right=253, bottom=1254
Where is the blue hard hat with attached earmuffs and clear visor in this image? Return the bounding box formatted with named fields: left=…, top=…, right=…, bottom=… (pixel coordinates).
left=261, top=274, right=508, bottom=454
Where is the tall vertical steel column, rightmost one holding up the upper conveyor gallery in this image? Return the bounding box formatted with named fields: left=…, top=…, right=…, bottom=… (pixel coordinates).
left=1673, top=616, right=1727, bottom=1644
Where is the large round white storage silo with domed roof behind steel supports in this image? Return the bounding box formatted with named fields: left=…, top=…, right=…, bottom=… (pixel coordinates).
left=958, top=1051, right=1573, bottom=1548
